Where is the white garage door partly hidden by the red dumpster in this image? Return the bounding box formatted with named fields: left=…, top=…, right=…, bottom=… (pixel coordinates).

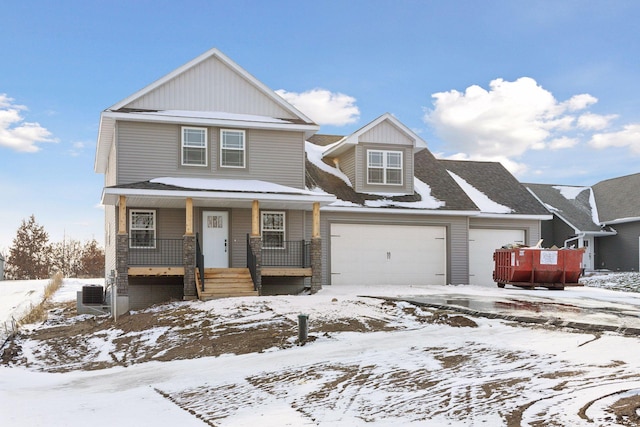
left=469, top=228, right=524, bottom=285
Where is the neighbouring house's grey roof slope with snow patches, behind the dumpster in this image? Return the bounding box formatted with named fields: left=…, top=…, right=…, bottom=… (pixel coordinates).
left=524, top=184, right=612, bottom=233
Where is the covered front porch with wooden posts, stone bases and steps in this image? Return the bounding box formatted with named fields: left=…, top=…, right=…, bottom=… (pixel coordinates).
left=103, top=180, right=334, bottom=311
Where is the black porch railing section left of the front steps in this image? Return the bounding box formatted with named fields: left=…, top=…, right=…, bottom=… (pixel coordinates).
left=129, top=238, right=184, bottom=266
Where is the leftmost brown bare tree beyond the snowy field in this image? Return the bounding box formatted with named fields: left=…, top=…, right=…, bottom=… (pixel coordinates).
left=6, top=215, right=51, bottom=280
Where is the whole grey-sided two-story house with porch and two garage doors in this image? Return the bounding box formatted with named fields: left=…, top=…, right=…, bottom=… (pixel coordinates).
left=95, top=49, right=551, bottom=313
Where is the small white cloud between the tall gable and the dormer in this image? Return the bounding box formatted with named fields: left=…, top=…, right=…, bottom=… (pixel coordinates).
left=276, top=89, right=360, bottom=126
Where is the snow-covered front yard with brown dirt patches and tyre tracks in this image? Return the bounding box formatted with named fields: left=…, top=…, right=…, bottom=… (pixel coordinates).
left=0, top=276, right=640, bottom=427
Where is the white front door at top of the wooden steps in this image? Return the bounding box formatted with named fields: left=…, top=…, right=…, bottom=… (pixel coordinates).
left=202, top=211, right=229, bottom=268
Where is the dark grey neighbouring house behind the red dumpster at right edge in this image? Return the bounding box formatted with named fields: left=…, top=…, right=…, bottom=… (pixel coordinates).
left=525, top=174, right=640, bottom=271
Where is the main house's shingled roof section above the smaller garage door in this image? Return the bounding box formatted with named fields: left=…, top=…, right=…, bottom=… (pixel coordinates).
left=439, top=160, right=550, bottom=219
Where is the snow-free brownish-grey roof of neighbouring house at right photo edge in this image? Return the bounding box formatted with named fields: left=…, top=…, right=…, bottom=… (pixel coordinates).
left=592, top=173, right=640, bottom=224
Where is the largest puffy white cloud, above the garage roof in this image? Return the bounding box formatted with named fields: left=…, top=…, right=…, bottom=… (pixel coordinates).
left=425, top=77, right=597, bottom=158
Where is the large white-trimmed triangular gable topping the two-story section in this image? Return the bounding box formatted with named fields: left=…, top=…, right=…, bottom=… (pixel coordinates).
left=94, top=48, right=319, bottom=173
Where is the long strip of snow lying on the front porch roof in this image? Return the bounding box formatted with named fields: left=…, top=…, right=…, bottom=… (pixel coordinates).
left=149, top=177, right=318, bottom=195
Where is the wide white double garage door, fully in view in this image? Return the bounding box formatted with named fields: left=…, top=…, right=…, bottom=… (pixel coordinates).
left=330, top=224, right=447, bottom=285
